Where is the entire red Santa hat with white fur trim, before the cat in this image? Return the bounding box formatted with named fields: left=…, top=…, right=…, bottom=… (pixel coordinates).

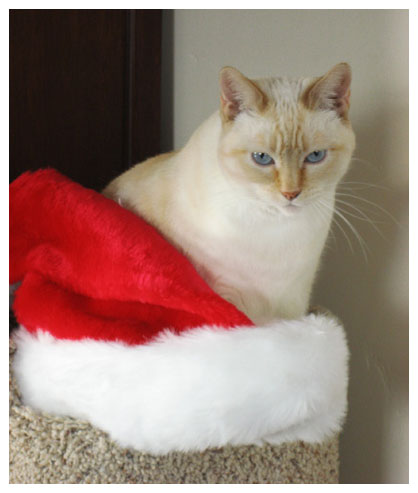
left=10, top=170, right=348, bottom=453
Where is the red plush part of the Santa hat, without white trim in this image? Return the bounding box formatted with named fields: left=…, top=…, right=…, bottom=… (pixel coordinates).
left=10, top=169, right=252, bottom=344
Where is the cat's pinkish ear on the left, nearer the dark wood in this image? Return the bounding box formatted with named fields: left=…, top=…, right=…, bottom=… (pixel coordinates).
left=219, top=67, right=267, bottom=121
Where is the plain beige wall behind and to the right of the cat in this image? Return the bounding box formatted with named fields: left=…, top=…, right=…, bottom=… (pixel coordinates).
left=162, top=10, right=408, bottom=483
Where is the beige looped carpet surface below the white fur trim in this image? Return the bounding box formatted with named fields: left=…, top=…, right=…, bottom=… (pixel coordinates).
left=9, top=336, right=338, bottom=484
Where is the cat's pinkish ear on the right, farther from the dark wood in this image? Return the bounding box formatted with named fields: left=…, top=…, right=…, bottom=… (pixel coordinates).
left=304, top=63, right=351, bottom=118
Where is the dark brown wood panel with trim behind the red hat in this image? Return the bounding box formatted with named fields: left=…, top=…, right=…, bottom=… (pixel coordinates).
left=10, top=10, right=161, bottom=189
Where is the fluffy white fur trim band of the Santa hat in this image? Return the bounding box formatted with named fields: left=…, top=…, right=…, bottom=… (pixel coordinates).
left=14, top=314, right=348, bottom=453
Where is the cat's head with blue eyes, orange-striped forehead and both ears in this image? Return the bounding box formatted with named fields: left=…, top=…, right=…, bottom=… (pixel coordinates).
left=219, top=63, right=355, bottom=215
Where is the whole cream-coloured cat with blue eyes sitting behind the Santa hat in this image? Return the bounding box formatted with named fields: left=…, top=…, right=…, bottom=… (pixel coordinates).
left=103, top=63, right=355, bottom=324
